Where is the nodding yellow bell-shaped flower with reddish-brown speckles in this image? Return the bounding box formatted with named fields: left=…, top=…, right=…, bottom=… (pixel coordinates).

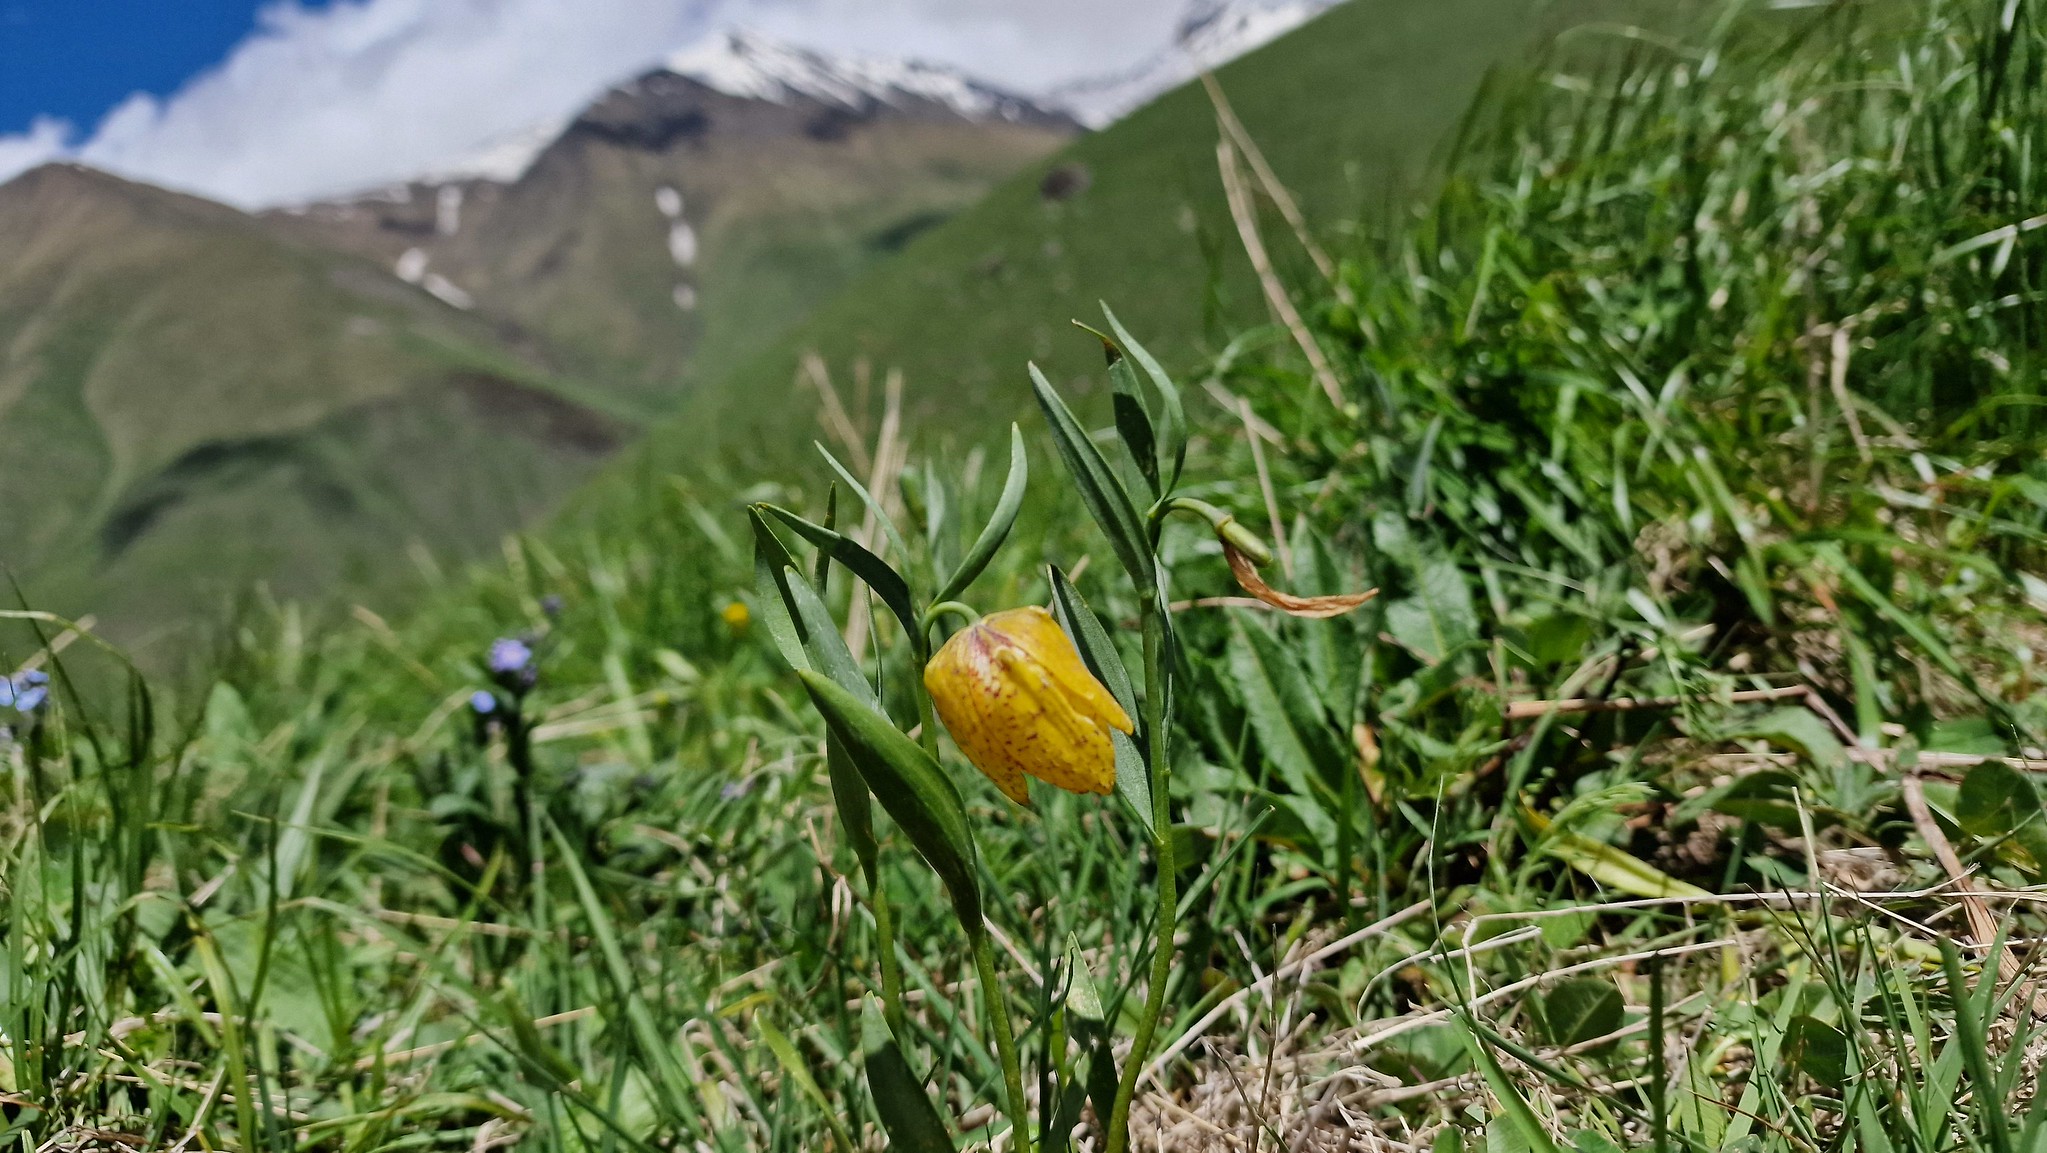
left=923, top=604, right=1134, bottom=805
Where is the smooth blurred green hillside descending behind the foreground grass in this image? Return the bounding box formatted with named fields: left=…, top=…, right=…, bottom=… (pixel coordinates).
left=655, top=0, right=1681, bottom=473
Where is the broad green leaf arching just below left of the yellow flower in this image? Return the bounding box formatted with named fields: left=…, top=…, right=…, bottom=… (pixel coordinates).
left=796, top=670, right=983, bottom=936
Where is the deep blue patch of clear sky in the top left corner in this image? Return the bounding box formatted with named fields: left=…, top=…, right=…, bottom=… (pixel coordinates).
left=0, top=0, right=319, bottom=133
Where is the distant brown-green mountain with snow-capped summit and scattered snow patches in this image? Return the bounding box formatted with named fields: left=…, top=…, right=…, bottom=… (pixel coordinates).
left=276, top=35, right=1075, bottom=414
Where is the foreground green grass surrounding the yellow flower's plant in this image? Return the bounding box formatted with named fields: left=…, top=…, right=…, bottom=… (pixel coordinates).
left=0, top=2, right=2047, bottom=1151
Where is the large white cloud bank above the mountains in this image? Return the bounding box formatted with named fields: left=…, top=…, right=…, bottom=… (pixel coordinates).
left=12, top=0, right=1187, bottom=207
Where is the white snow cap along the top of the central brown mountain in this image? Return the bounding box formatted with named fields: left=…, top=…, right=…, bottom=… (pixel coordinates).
left=667, top=31, right=1044, bottom=121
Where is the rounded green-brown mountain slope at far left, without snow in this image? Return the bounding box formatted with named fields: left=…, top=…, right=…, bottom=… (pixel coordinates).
left=0, top=166, right=624, bottom=639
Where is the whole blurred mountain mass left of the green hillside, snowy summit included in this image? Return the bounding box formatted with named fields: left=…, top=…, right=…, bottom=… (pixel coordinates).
left=0, top=39, right=1075, bottom=655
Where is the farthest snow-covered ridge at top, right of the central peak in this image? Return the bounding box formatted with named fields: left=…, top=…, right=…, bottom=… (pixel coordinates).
left=1046, top=0, right=1341, bottom=127
